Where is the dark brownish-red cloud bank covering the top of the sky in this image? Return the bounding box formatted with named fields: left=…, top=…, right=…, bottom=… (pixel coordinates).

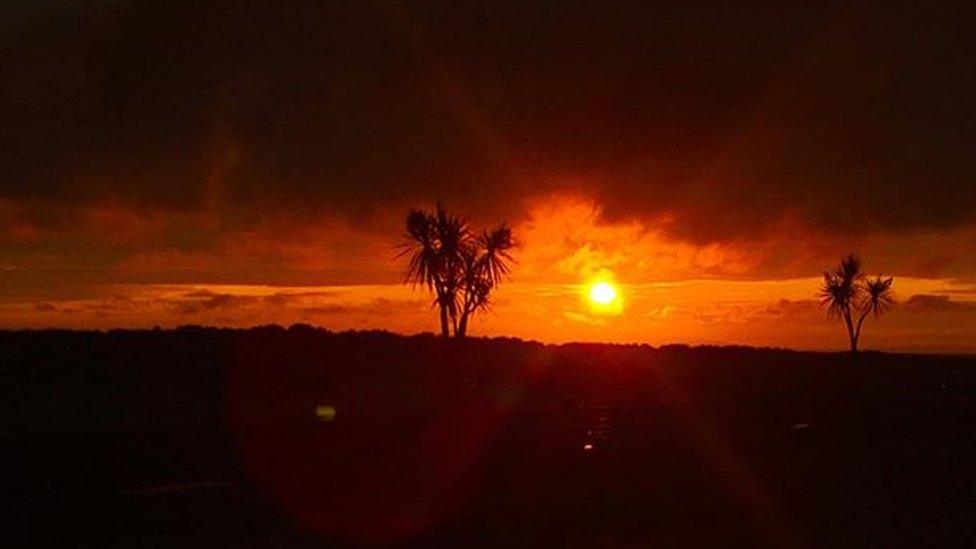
left=0, top=1, right=976, bottom=242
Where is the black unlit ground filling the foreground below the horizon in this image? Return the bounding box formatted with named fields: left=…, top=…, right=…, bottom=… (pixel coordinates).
left=0, top=327, right=976, bottom=547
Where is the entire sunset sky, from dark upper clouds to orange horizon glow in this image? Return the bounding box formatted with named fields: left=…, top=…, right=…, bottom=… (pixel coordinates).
left=0, top=0, right=976, bottom=352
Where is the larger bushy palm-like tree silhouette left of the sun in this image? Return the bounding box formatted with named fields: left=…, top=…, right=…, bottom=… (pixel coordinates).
left=401, top=204, right=515, bottom=337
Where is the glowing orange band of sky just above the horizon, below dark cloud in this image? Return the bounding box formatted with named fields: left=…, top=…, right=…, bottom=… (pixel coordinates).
left=0, top=196, right=976, bottom=351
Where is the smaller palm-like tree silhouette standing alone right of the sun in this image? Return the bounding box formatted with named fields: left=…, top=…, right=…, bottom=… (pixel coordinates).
left=820, top=254, right=895, bottom=353
